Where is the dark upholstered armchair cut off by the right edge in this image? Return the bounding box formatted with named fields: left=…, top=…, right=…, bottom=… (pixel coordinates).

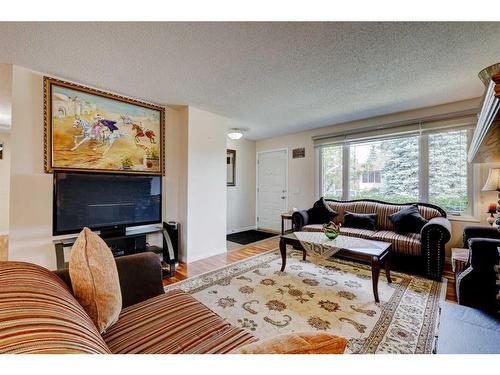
left=456, top=226, right=500, bottom=312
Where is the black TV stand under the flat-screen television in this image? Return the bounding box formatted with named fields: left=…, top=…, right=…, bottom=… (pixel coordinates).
left=53, top=227, right=176, bottom=277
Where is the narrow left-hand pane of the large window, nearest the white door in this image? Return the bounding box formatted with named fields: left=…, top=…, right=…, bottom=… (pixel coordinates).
left=321, top=146, right=342, bottom=199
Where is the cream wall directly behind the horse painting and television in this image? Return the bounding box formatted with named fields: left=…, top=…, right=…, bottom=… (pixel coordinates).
left=9, top=66, right=195, bottom=269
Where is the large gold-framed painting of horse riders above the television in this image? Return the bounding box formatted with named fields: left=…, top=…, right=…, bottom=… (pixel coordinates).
left=44, top=77, right=165, bottom=175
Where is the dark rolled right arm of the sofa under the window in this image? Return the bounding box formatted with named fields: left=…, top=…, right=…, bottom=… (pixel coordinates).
left=420, top=217, right=451, bottom=280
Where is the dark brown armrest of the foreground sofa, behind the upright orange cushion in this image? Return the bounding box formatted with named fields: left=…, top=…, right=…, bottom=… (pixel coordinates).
left=54, top=252, right=165, bottom=308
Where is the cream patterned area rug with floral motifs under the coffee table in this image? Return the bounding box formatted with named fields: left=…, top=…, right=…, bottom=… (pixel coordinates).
left=165, top=251, right=446, bottom=354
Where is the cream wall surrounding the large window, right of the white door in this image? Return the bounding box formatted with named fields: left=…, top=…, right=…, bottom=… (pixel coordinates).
left=256, top=99, right=495, bottom=256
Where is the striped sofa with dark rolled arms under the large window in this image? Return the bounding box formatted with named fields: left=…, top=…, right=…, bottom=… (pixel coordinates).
left=292, top=199, right=451, bottom=280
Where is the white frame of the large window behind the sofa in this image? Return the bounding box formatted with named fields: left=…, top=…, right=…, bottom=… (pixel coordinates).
left=315, top=127, right=475, bottom=217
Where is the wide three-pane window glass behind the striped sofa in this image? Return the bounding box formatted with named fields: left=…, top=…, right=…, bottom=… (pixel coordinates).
left=319, top=130, right=470, bottom=213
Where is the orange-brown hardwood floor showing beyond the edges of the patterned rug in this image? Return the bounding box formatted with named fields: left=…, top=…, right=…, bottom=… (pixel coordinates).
left=163, top=237, right=457, bottom=302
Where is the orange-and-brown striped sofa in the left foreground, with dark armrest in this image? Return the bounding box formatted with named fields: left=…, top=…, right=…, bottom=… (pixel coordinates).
left=0, top=253, right=347, bottom=354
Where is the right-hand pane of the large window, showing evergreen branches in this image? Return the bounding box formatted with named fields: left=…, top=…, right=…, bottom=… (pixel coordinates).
left=429, top=130, right=469, bottom=212
